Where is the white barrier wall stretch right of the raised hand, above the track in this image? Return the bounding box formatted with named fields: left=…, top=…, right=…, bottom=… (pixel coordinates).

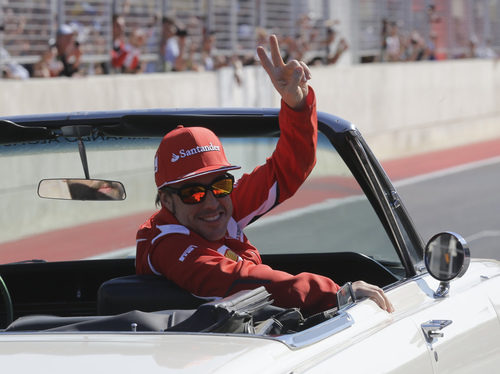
left=314, top=60, right=500, bottom=158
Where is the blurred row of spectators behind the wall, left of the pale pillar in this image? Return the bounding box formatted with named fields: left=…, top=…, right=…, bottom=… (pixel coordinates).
left=0, top=9, right=349, bottom=83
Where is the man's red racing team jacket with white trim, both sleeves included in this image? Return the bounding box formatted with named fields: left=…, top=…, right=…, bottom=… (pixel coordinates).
left=136, top=88, right=339, bottom=314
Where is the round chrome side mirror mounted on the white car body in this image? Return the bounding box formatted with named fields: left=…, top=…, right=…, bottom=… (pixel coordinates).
left=424, top=232, right=470, bottom=297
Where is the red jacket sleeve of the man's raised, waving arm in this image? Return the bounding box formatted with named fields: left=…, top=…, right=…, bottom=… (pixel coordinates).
left=231, top=87, right=318, bottom=229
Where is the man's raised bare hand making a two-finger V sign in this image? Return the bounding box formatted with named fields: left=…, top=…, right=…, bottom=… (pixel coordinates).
left=257, top=35, right=311, bottom=110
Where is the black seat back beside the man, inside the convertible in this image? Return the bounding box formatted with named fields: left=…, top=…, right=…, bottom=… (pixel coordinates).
left=97, top=275, right=207, bottom=315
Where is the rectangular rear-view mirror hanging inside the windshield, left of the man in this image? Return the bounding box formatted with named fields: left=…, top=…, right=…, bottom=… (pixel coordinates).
left=38, top=179, right=126, bottom=200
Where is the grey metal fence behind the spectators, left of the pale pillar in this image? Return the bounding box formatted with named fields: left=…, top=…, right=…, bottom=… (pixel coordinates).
left=0, top=0, right=332, bottom=74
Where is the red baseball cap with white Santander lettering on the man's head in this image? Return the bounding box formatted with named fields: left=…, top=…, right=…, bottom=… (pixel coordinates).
left=155, top=126, right=240, bottom=188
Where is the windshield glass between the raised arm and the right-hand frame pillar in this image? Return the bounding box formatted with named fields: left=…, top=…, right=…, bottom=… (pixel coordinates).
left=238, top=134, right=399, bottom=262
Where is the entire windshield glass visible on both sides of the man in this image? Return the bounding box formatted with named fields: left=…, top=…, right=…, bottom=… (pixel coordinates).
left=0, top=130, right=399, bottom=264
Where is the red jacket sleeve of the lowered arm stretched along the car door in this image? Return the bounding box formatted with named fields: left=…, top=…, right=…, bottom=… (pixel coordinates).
left=150, top=235, right=340, bottom=315
